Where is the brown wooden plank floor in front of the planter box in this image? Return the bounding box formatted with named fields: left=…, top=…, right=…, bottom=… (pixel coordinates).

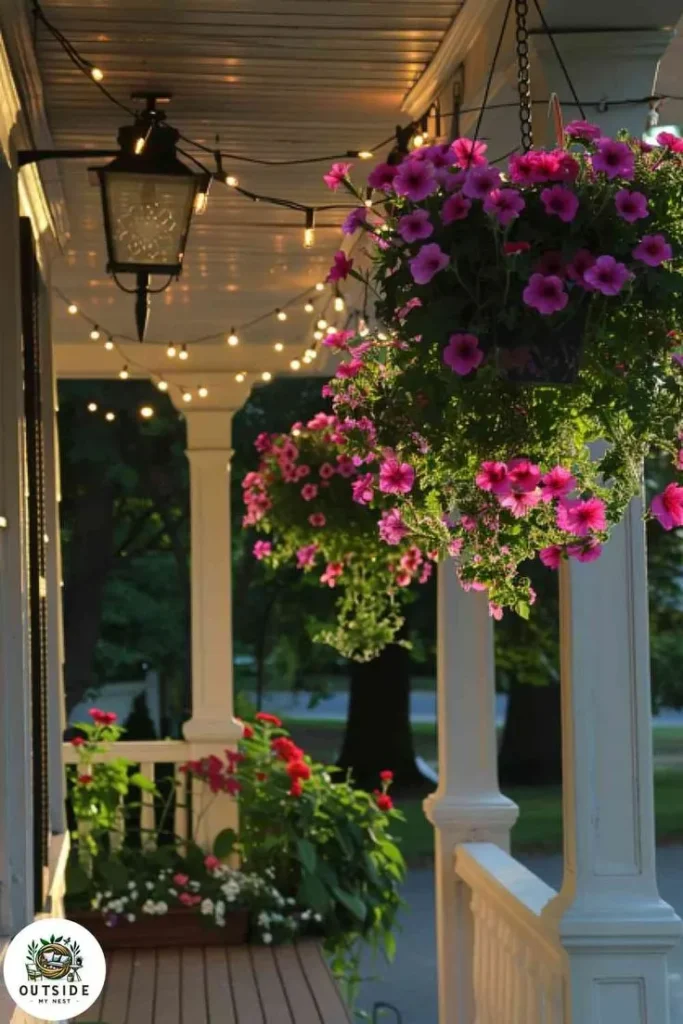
left=77, top=942, right=350, bottom=1024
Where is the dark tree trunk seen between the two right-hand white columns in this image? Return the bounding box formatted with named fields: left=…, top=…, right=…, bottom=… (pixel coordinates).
left=499, top=679, right=562, bottom=788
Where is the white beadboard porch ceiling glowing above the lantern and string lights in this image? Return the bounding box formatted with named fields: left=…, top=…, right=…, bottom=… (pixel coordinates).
left=37, top=0, right=462, bottom=356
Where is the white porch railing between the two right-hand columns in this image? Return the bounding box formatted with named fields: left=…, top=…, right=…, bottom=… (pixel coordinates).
left=456, top=843, right=567, bottom=1024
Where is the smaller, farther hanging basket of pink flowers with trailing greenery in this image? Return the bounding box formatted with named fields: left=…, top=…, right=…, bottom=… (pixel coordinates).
left=242, top=409, right=434, bottom=662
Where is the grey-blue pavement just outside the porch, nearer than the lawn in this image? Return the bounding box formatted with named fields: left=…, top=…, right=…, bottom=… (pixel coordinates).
left=360, top=846, right=683, bottom=1024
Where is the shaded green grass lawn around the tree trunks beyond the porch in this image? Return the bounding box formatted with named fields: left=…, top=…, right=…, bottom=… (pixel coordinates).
left=287, top=719, right=683, bottom=863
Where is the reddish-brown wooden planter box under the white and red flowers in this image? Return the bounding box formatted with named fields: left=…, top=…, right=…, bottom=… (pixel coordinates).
left=67, top=907, right=249, bottom=949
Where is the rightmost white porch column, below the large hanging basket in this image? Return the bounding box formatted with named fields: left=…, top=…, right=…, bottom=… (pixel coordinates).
left=547, top=499, right=682, bottom=1024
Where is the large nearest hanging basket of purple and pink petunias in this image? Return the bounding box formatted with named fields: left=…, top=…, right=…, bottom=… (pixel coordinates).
left=321, top=122, right=683, bottom=616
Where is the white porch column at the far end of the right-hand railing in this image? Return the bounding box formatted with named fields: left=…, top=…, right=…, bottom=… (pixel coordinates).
left=424, top=563, right=518, bottom=1024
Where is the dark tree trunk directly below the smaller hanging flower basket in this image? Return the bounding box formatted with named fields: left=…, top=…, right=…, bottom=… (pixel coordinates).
left=338, top=644, right=427, bottom=791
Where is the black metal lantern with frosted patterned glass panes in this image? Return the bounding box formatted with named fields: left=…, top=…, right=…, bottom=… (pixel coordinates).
left=93, top=96, right=205, bottom=341
